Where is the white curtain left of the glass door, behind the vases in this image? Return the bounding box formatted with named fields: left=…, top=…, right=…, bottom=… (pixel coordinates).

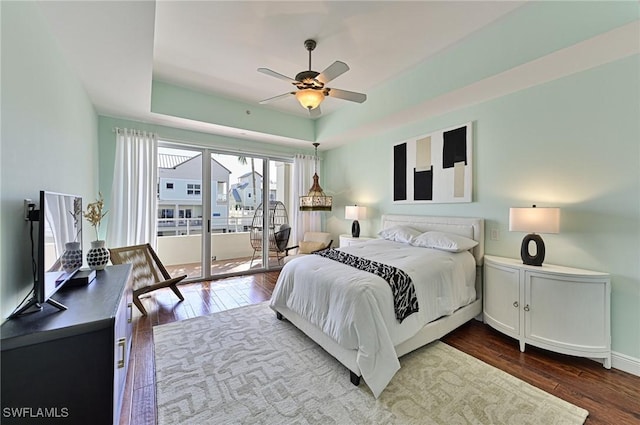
left=107, top=129, right=158, bottom=249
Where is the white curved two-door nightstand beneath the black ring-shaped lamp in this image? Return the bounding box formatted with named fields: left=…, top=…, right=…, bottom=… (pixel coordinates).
left=484, top=255, right=611, bottom=369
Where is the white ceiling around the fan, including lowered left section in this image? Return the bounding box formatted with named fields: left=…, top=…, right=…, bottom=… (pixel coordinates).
left=39, top=1, right=523, bottom=144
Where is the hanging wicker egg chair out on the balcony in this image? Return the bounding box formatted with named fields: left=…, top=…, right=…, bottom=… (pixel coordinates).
left=249, top=201, right=291, bottom=267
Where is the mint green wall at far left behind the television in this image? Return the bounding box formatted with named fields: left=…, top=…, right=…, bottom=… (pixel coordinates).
left=0, top=1, right=98, bottom=319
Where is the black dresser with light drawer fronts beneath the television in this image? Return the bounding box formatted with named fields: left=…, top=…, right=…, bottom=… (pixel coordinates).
left=0, top=264, right=133, bottom=425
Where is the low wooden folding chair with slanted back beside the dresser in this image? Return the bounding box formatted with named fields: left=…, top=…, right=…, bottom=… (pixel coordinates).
left=110, top=244, right=187, bottom=316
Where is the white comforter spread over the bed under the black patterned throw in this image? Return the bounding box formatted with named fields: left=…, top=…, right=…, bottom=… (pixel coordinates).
left=271, top=239, right=476, bottom=397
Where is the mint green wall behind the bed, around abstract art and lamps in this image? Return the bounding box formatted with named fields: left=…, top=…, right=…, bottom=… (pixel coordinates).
left=321, top=55, right=640, bottom=359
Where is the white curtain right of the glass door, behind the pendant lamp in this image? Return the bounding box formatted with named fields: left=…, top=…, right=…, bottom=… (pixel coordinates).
left=290, top=154, right=322, bottom=244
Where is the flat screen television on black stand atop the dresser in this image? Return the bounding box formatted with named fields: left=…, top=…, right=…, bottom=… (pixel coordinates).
left=14, top=190, right=83, bottom=315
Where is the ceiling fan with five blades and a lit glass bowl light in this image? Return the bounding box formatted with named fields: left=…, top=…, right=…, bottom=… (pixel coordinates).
left=258, top=40, right=367, bottom=117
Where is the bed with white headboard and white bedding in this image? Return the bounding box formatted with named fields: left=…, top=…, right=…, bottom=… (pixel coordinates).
left=270, top=215, right=484, bottom=398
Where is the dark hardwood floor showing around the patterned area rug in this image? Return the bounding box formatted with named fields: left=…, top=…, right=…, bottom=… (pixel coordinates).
left=120, top=272, right=640, bottom=425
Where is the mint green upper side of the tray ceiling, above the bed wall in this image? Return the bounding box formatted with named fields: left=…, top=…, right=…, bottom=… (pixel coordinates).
left=316, top=1, right=640, bottom=143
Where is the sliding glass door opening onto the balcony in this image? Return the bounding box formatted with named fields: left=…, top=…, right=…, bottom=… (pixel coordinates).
left=158, top=143, right=292, bottom=280
